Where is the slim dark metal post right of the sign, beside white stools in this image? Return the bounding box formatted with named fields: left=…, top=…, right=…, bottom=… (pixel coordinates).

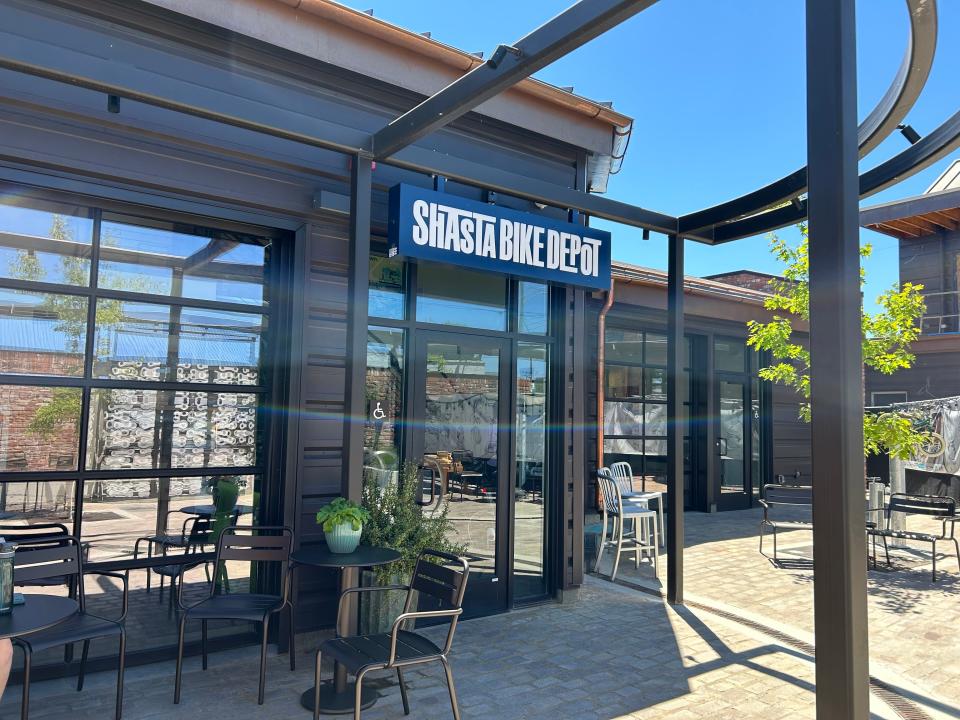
left=667, top=235, right=687, bottom=603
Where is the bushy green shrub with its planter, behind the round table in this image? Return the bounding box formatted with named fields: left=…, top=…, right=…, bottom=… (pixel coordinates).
left=360, top=462, right=466, bottom=634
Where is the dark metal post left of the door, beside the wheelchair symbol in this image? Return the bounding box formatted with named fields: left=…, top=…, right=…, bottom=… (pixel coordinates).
left=342, top=155, right=373, bottom=501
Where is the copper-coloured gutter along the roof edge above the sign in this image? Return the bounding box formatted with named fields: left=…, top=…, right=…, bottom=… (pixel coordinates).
left=272, top=0, right=632, bottom=129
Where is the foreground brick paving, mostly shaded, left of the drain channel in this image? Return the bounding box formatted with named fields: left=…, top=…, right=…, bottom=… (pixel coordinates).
left=0, top=578, right=896, bottom=720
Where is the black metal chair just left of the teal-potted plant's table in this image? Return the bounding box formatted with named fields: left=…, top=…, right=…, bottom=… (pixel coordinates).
left=173, top=526, right=296, bottom=705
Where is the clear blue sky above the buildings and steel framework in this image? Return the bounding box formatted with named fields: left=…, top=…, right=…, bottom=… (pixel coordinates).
left=347, top=0, right=960, bottom=312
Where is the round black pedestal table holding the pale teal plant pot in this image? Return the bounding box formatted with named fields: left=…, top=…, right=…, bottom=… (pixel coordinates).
left=290, top=545, right=400, bottom=715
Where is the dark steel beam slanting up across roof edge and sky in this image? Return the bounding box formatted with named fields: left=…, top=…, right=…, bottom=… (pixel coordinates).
left=371, top=0, right=657, bottom=159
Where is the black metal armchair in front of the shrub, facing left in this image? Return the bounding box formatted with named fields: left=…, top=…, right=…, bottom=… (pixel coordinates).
left=313, top=550, right=470, bottom=720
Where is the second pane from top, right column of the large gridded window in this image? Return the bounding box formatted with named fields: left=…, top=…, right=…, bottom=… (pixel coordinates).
left=94, top=298, right=265, bottom=385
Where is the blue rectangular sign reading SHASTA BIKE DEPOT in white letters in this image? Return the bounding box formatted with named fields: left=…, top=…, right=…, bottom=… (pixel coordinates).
left=390, top=183, right=610, bottom=289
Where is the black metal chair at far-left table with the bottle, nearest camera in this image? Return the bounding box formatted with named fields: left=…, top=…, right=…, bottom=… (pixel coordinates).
left=13, top=537, right=129, bottom=720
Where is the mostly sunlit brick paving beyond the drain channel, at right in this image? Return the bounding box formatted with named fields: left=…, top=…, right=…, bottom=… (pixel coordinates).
left=590, top=510, right=960, bottom=718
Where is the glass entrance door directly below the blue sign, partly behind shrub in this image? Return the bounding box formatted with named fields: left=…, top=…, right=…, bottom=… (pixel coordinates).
left=411, top=332, right=510, bottom=615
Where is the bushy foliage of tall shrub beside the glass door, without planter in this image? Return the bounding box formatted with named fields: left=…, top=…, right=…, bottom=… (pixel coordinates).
left=361, top=462, right=466, bottom=584
